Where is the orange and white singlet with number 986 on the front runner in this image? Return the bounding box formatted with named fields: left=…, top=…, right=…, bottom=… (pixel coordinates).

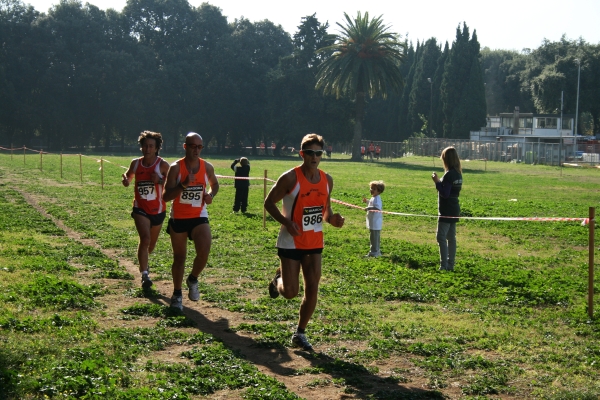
left=277, top=167, right=329, bottom=250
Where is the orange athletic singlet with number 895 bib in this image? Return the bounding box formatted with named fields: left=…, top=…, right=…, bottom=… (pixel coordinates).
left=170, top=158, right=208, bottom=219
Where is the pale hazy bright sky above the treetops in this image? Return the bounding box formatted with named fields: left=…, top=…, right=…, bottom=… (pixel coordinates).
left=23, top=0, right=600, bottom=51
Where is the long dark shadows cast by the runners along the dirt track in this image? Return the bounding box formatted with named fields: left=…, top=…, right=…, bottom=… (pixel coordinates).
left=148, top=295, right=445, bottom=400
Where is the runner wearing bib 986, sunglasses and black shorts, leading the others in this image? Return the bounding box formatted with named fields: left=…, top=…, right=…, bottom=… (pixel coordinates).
left=264, top=133, right=344, bottom=351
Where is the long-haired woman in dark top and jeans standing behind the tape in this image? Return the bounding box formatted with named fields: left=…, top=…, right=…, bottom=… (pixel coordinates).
left=431, top=147, right=462, bottom=271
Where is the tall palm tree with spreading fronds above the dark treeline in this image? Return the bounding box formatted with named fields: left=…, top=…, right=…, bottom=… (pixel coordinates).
left=315, top=12, right=406, bottom=161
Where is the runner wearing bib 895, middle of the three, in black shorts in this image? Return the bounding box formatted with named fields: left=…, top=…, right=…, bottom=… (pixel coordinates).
left=163, top=132, right=219, bottom=310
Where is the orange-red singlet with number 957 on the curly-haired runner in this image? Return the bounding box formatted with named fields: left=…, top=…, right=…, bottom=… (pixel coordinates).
left=133, top=157, right=166, bottom=215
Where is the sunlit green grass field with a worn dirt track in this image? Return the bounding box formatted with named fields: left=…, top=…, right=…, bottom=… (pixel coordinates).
left=0, top=153, right=600, bottom=399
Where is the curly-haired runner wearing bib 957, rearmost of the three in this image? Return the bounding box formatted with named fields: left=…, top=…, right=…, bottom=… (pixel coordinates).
left=121, top=131, right=169, bottom=289
